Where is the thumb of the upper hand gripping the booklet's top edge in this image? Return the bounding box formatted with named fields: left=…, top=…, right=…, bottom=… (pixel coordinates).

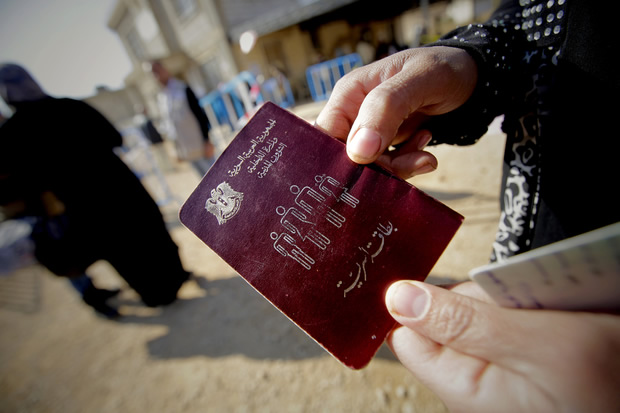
left=347, top=47, right=477, bottom=163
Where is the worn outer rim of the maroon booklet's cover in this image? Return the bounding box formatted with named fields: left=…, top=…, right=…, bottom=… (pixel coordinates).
left=178, top=101, right=465, bottom=370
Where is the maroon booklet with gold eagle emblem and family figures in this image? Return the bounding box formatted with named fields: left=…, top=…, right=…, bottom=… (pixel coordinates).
left=180, top=103, right=463, bottom=369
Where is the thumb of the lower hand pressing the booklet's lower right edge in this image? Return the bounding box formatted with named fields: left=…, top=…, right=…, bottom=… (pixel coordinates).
left=386, top=281, right=620, bottom=388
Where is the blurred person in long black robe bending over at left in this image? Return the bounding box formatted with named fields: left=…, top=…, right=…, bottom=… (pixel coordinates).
left=0, top=64, right=189, bottom=317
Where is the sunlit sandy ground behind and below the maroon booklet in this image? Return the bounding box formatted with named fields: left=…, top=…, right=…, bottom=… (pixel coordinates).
left=0, top=101, right=504, bottom=413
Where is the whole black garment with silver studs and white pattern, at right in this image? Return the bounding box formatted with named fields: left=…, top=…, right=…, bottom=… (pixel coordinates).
left=429, top=0, right=620, bottom=261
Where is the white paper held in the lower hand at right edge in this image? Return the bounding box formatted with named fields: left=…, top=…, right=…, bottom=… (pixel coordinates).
left=469, top=223, right=620, bottom=310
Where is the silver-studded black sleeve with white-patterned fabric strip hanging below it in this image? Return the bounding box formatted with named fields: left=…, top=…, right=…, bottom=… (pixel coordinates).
left=430, top=0, right=567, bottom=261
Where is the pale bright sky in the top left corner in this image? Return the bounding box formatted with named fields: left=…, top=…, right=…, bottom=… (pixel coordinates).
left=0, top=0, right=131, bottom=98
